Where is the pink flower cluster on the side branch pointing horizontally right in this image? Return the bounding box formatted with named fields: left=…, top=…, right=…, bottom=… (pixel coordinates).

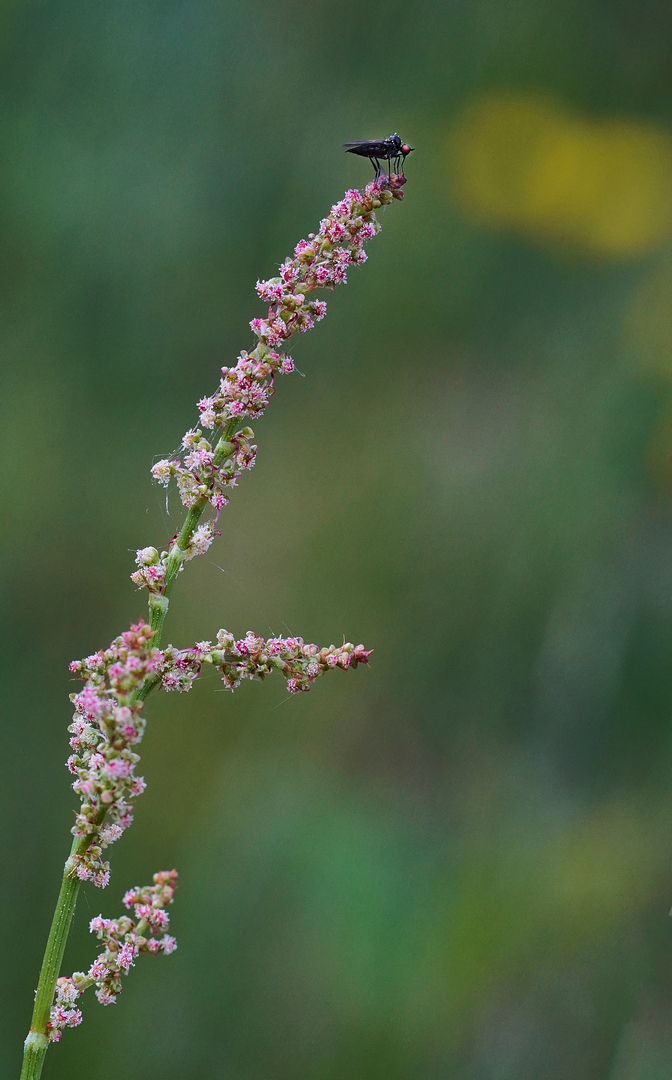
left=162, top=630, right=371, bottom=693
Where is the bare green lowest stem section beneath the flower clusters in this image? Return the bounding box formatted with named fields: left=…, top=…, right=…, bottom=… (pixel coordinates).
left=21, top=836, right=98, bottom=1080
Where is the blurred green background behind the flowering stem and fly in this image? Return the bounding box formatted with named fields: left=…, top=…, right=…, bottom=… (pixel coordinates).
left=0, top=0, right=672, bottom=1080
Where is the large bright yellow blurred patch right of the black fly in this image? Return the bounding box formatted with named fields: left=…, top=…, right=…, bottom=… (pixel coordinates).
left=449, top=94, right=672, bottom=258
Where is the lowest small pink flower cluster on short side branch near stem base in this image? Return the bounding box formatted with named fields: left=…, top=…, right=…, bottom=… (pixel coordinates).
left=48, top=870, right=177, bottom=1042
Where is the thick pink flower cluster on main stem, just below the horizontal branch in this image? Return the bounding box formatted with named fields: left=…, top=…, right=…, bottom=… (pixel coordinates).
left=67, top=621, right=163, bottom=888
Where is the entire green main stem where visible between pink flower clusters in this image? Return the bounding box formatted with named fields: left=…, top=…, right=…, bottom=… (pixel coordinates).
left=21, top=420, right=238, bottom=1080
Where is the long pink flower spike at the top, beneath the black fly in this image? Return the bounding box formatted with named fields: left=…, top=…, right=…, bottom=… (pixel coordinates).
left=132, top=175, right=406, bottom=593
